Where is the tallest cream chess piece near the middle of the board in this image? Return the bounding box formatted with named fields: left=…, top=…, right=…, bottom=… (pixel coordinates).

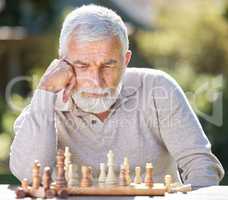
left=105, top=150, right=117, bottom=185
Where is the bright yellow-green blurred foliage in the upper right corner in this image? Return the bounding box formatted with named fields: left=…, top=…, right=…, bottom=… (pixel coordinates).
left=138, top=1, right=228, bottom=74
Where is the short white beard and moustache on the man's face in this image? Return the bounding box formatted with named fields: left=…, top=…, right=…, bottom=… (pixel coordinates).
left=72, top=81, right=122, bottom=114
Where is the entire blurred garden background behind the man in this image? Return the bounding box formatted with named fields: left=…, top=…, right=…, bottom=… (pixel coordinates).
left=0, top=0, right=228, bottom=185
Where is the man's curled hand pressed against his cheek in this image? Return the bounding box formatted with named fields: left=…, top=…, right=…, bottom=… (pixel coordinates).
left=38, top=59, right=76, bottom=102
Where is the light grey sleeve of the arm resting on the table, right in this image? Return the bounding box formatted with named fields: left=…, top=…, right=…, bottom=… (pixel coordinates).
left=154, top=73, right=224, bottom=188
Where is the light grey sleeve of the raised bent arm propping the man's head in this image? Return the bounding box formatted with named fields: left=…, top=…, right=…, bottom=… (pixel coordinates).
left=9, top=89, right=56, bottom=182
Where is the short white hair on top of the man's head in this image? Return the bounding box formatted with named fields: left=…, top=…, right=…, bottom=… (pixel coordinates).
left=59, top=4, right=129, bottom=56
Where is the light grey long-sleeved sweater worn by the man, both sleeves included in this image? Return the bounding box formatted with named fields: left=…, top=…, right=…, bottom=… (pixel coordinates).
left=10, top=68, right=224, bottom=187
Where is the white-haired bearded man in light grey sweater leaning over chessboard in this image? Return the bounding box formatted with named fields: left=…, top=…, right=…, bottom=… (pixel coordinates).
left=10, top=5, right=224, bottom=188
